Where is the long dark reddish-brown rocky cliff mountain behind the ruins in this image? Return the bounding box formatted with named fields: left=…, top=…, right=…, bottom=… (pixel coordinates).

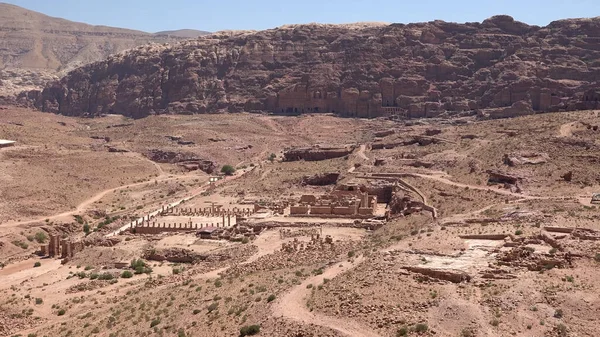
left=21, top=16, right=600, bottom=117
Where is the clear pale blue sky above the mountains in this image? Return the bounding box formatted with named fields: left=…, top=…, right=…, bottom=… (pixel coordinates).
left=0, top=0, right=600, bottom=32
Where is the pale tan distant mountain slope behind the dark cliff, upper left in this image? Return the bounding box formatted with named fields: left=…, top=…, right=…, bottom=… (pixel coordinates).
left=0, top=3, right=209, bottom=94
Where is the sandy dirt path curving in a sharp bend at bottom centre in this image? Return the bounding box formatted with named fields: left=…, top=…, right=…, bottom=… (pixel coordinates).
left=273, top=256, right=380, bottom=337
